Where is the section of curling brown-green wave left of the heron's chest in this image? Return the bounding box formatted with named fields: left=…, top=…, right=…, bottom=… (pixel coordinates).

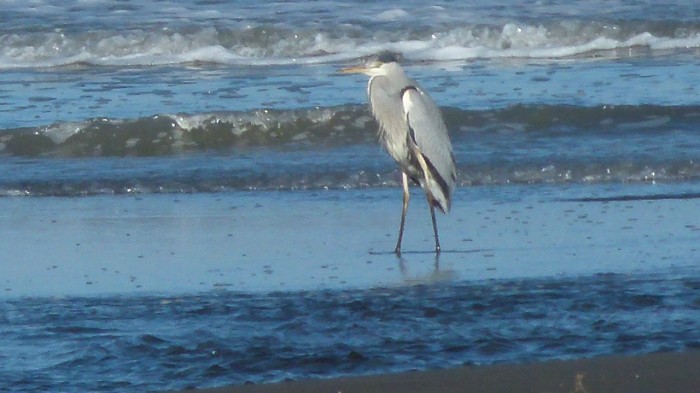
left=0, top=106, right=374, bottom=157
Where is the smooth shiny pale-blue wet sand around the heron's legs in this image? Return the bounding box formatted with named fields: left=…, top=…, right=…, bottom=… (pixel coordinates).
left=0, top=187, right=700, bottom=296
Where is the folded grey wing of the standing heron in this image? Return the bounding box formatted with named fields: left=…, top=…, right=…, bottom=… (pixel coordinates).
left=402, top=86, right=457, bottom=211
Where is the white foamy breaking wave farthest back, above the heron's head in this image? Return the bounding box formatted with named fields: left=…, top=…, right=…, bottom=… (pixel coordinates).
left=0, top=19, right=700, bottom=69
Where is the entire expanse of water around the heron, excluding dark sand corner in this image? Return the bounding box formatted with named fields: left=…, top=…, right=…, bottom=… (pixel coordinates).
left=0, top=0, right=700, bottom=392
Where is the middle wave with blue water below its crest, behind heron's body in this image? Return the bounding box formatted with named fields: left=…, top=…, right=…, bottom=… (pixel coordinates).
left=0, top=105, right=700, bottom=196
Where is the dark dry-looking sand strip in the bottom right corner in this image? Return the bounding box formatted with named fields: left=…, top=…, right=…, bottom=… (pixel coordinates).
left=176, top=351, right=700, bottom=393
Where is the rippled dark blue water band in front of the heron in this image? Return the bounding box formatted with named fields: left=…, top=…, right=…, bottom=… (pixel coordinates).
left=0, top=271, right=700, bottom=392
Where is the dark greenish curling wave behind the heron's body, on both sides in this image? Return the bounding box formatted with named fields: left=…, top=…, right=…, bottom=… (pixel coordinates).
left=0, top=104, right=700, bottom=157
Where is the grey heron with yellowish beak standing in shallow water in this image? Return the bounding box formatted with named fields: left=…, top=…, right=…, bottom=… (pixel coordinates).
left=341, top=52, right=457, bottom=254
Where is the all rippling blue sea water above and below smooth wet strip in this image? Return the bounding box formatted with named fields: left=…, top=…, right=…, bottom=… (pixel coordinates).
left=0, top=0, right=700, bottom=392
